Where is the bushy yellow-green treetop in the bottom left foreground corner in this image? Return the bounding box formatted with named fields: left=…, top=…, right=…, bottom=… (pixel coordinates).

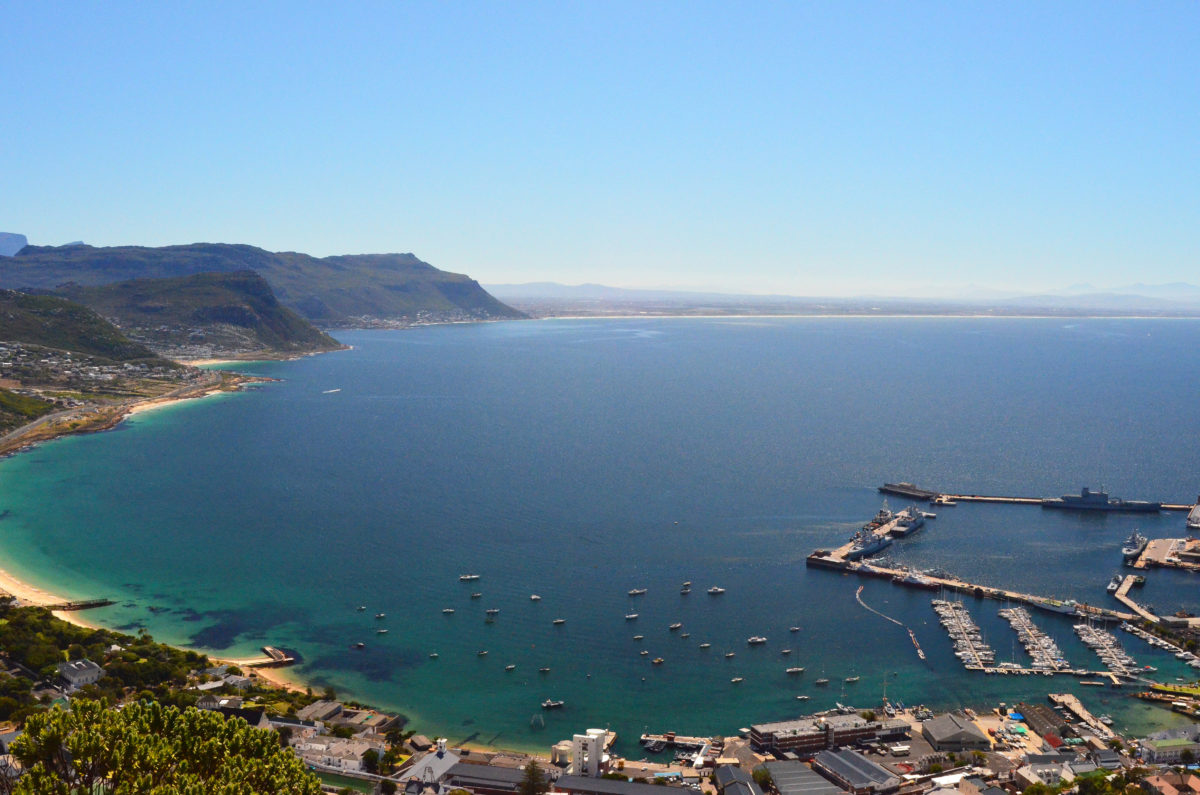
left=13, top=699, right=320, bottom=795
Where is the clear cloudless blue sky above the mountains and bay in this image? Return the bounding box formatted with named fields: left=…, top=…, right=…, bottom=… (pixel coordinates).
left=0, top=1, right=1200, bottom=294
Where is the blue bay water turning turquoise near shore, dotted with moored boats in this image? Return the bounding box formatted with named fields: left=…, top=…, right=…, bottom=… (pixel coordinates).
left=0, top=318, right=1200, bottom=747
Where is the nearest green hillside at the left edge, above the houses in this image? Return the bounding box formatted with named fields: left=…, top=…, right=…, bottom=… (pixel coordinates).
left=0, top=289, right=166, bottom=364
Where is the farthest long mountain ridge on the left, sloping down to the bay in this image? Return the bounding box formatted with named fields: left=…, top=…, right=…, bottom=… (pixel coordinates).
left=0, top=243, right=523, bottom=328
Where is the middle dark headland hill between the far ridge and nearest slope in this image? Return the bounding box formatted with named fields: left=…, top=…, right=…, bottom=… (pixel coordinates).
left=54, top=270, right=342, bottom=358
